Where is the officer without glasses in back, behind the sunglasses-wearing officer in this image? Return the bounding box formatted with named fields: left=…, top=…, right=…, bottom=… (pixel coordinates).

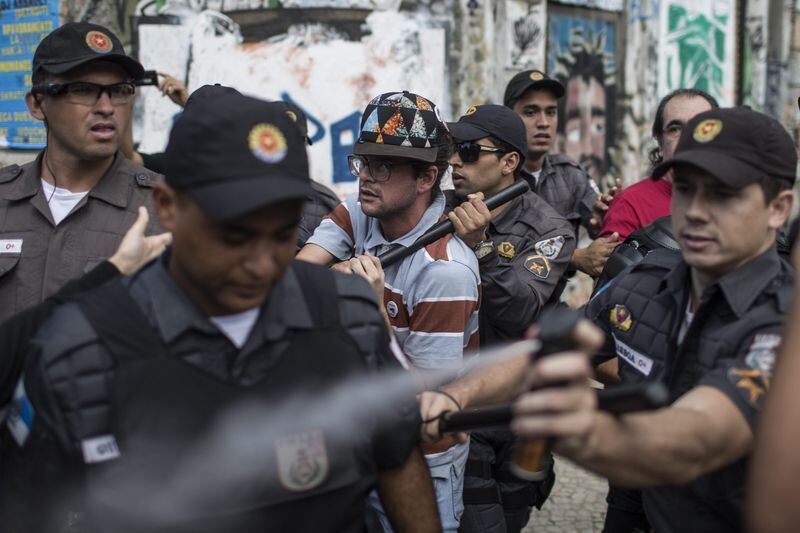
left=503, top=70, right=617, bottom=276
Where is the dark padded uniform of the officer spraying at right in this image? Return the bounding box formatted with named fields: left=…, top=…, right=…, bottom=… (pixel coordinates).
left=586, top=247, right=793, bottom=533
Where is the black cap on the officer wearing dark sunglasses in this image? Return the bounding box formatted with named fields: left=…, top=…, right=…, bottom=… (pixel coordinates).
left=447, top=104, right=528, bottom=166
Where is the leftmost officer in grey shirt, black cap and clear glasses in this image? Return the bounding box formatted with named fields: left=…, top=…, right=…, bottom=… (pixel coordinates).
left=0, top=22, right=161, bottom=320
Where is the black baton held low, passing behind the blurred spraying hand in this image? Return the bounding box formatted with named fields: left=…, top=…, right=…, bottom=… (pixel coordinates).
left=439, top=383, right=669, bottom=433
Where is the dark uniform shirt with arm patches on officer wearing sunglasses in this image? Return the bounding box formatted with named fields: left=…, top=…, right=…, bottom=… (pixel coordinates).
left=478, top=191, right=575, bottom=345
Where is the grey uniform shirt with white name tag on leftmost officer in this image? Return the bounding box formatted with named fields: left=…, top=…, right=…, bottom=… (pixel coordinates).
left=0, top=153, right=158, bottom=320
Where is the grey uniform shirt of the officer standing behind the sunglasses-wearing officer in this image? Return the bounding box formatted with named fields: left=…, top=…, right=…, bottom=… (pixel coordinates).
left=522, top=154, right=600, bottom=235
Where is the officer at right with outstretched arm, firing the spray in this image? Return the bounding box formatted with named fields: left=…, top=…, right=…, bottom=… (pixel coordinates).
left=514, top=108, right=797, bottom=533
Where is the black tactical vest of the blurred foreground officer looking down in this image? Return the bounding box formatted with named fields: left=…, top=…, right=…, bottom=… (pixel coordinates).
left=3, top=263, right=382, bottom=533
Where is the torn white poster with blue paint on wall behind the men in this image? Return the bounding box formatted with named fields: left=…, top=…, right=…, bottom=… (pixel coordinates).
left=139, top=6, right=449, bottom=194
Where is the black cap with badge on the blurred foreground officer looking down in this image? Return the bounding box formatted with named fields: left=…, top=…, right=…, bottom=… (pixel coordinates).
left=165, top=93, right=311, bottom=220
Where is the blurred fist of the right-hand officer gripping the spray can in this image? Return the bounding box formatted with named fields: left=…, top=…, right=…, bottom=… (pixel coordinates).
left=512, top=320, right=603, bottom=456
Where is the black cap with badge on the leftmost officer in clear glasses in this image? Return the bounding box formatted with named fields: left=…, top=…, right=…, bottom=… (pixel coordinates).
left=33, top=22, right=144, bottom=80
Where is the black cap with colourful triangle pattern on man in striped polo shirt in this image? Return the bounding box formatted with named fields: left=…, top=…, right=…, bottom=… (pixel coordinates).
left=353, top=91, right=447, bottom=163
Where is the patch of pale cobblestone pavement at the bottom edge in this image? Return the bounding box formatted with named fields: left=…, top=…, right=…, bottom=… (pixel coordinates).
left=523, top=457, right=608, bottom=533
